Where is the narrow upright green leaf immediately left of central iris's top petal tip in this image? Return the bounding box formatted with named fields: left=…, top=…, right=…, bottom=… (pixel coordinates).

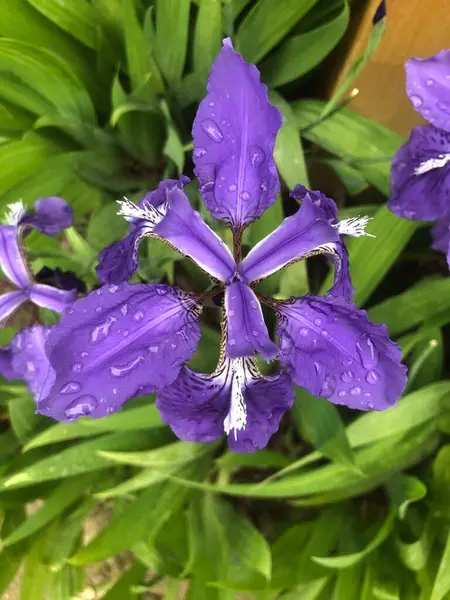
left=194, top=0, right=222, bottom=80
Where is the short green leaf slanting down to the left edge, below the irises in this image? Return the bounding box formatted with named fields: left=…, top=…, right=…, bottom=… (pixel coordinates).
left=2, top=475, right=93, bottom=547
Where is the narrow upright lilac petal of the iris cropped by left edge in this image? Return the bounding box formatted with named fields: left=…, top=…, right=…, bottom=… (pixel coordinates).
left=0, top=225, right=32, bottom=288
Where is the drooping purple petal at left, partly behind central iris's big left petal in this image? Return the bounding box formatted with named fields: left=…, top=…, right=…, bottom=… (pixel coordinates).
left=9, top=325, right=54, bottom=400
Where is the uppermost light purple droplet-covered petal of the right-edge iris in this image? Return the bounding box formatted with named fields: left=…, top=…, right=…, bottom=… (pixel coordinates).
left=405, top=50, right=450, bottom=131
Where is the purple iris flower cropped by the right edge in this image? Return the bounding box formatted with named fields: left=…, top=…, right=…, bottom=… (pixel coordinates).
left=388, top=50, right=450, bottom=265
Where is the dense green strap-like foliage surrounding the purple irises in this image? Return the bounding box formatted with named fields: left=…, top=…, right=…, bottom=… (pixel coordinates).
left=0, top=0, right=450, bottom=600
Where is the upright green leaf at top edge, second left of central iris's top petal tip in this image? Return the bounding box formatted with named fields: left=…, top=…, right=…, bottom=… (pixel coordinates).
left=154, top=0, right=191, bottom=84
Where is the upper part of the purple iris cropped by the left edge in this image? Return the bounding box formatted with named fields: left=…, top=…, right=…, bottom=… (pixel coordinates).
left=0, top=197, right=76, bottom=324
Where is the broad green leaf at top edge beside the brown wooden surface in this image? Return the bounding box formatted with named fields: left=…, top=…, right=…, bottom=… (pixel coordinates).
left=261, top=0, right=350, bottom=87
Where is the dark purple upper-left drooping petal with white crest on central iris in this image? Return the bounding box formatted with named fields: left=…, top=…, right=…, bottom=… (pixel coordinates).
left=96, top=176, right=189, bottom=284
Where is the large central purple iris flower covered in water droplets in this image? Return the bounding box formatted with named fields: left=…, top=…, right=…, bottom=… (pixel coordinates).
left=38, top=40, right=406, bottom=452
